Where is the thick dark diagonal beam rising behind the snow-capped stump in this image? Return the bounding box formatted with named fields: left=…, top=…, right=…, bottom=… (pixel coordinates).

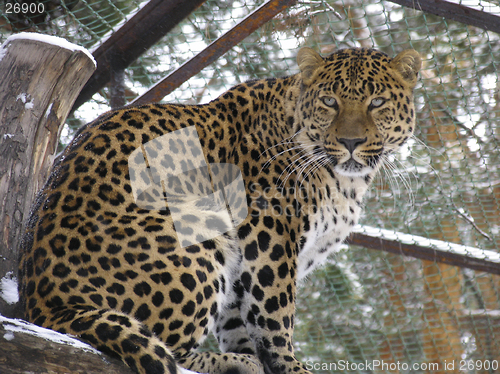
left=71, top=0, right=206, bottom=111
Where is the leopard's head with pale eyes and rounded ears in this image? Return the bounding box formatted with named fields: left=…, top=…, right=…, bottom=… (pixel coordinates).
left=295, top=48, right=421, bottom=177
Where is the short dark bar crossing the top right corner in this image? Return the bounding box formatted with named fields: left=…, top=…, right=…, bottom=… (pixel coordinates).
left=390, top=0, right=500, bottom=33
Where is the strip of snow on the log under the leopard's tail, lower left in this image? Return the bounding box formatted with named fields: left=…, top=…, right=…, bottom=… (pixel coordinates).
left=0, top=315, right=101, bottom=355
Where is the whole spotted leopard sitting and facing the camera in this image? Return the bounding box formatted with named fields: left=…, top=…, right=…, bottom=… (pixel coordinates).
left=19, top=47, right=422, bottom=374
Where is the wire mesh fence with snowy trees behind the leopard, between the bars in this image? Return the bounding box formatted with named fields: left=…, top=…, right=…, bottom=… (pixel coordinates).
left=0, top=0, right=500, bottom=373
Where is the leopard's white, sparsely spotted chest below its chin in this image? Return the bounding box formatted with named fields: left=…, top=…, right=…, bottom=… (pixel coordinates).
left=298, top=180, right=365, bottom=279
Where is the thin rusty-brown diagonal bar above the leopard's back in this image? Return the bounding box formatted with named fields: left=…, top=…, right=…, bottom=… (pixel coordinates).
left=133, top=0, right=296, bottom=104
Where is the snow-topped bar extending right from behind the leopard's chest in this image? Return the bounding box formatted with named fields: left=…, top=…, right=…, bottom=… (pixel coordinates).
left=347, top=229, right=500, bottom=275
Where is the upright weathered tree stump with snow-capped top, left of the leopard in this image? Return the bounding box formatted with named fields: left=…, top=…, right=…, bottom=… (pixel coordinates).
left=0, top=33, right=95, bottom=316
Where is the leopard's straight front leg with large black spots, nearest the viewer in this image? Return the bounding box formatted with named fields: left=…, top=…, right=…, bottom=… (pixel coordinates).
left=235, top=215, right=310, bottom=374
